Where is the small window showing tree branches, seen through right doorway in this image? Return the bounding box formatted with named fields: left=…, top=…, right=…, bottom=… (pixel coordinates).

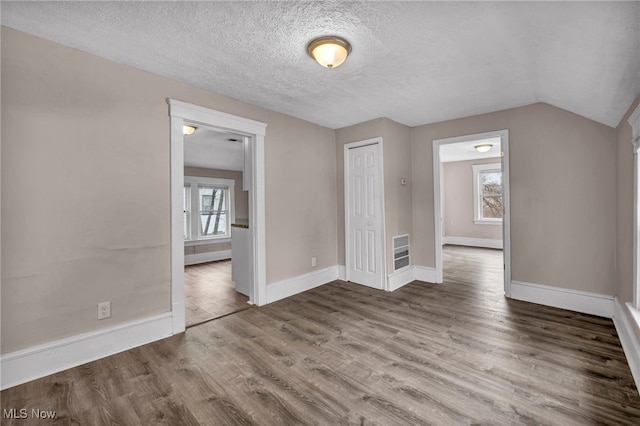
left=472, top=163, right=504, bottom=225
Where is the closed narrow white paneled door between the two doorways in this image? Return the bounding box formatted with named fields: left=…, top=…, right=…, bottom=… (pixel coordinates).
left=344, top=138, right=386, bottom=290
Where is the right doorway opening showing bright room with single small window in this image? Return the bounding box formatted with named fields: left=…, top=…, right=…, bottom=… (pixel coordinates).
left=433, top=130, right=511, bottom=297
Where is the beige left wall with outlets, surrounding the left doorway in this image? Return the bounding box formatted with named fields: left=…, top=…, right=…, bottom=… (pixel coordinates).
left=1, top=27, right=337, bottom=353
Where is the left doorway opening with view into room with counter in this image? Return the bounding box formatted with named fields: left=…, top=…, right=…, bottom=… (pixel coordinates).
left=184, top=125, right=250, bottom=328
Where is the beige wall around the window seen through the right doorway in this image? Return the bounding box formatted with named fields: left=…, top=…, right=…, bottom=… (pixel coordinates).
left=440, top=158, right=502, bottom=240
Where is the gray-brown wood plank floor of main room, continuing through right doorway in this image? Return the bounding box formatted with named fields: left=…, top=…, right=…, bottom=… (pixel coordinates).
left=1, top=247, right=640, bottom=426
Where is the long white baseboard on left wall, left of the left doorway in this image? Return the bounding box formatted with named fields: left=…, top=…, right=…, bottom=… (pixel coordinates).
left=0, top=312, right=173, bottom=390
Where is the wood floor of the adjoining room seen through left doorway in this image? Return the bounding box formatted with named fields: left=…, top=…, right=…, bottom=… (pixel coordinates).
left=184, top=260, right=251, bottom=327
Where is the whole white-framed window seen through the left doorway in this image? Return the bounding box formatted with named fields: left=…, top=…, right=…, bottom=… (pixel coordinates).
left=184, top=176, right=235, bottom=241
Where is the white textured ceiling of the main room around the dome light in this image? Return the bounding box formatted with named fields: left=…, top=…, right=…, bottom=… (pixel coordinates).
left=1, top=1, right=640, bottom=128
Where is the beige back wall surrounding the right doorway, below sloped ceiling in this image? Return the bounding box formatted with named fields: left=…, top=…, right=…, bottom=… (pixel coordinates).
left=412, top=104, right=616, bottom=294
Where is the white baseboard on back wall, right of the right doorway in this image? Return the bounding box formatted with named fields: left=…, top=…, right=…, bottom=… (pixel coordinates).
left=511, top=281, right=614, bottom=318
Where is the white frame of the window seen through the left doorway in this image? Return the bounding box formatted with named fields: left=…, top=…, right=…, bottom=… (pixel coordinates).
left=184, top=176, right=236, bottom=245
